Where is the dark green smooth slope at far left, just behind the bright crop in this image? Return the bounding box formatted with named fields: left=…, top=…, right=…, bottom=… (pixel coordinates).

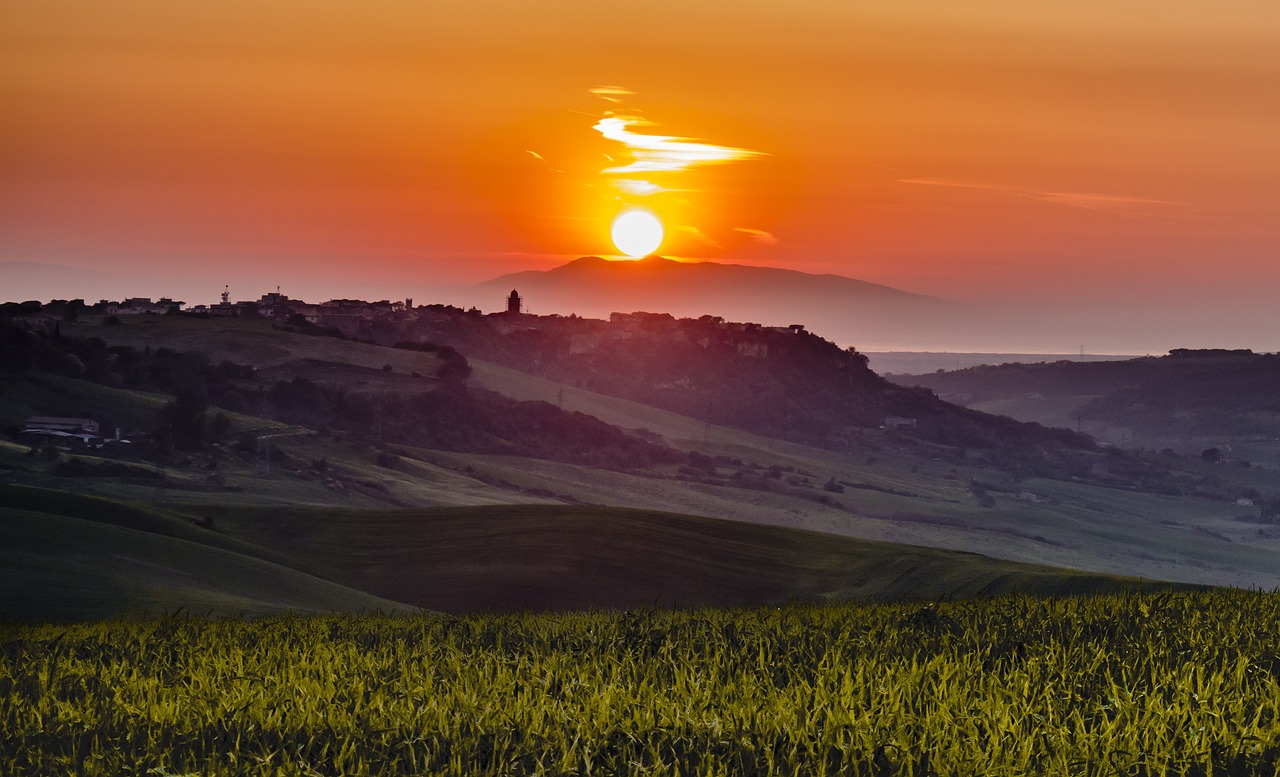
left=0, top=489, right=410, bottom=621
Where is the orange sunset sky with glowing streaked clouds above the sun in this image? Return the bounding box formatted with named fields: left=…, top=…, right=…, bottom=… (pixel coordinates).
left=0, top=0, right=1280, bottom=352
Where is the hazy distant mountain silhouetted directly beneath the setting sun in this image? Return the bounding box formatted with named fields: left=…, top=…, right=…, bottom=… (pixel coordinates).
left=472, top=256, right=973, bottom=349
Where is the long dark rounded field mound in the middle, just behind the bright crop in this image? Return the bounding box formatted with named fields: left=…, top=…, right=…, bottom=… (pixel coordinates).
left=197, top=504, right=1187, bottom=612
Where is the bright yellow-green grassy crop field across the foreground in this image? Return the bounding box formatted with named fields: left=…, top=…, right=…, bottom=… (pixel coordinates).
left=0, top=590, right=1280, bottom=777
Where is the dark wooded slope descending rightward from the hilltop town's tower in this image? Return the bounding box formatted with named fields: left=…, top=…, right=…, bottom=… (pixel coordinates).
left=360, top=308, right=1111, bottom=465
